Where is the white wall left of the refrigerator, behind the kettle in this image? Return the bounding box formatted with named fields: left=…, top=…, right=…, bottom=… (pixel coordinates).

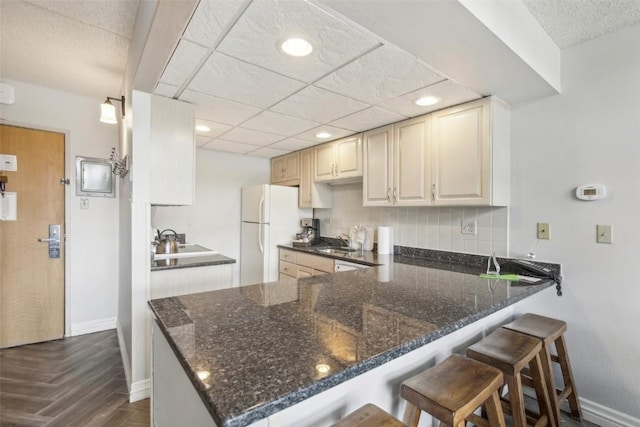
left=151, top=149, right=271, bottom=285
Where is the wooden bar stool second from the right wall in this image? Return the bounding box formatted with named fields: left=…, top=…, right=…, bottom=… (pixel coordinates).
left=467, top=329, right=557, bottom=427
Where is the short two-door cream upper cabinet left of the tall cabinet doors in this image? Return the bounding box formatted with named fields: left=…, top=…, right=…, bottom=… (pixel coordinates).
left=314, top=134, right=362, bottom=182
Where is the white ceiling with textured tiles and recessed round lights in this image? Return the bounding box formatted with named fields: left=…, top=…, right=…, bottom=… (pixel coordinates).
left=0, top=0, right=640, bottom=158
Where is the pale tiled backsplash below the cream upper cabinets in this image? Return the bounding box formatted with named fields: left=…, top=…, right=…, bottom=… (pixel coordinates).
left=314, top=184, right=509, bottom=257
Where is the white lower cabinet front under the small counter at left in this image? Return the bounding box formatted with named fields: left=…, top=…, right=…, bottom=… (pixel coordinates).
left=151, top=264, right=233, bottom=299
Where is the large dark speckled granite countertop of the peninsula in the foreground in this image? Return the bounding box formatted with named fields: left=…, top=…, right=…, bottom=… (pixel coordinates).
left=149, top=255, right=554, bottom=427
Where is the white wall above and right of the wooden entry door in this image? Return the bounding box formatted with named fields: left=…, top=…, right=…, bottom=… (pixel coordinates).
left=0, top=80, right=119, bottom=335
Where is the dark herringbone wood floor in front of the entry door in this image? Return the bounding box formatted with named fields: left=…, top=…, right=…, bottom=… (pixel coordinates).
left=0, top=330, right=149, bottom=427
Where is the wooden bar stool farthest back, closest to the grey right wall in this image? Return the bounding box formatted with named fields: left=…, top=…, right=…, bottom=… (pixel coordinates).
left=503, top=313, right=582, bottom=425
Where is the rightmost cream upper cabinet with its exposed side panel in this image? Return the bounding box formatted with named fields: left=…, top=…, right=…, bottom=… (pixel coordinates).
left=431, top=97, right=510, bottom=206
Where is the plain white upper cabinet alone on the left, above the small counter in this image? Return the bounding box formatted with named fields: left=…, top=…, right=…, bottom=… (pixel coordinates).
left=149, top=95, right=195, bottom=205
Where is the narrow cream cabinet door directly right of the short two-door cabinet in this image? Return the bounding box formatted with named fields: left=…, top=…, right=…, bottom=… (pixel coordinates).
left=362, top=125, right=393, bottom=206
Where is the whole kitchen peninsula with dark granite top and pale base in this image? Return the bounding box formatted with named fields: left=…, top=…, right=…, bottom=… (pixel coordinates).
left=150, top=255, right=554, bottom=427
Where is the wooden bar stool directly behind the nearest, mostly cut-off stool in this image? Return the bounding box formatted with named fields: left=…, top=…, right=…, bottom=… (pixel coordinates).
left=400, top=354, right=505, bottom=427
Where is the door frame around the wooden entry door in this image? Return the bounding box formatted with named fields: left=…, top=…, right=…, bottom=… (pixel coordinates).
left=0, top=118, right=75, bottom=337
